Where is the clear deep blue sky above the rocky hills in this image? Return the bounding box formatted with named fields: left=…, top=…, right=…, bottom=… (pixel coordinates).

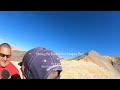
left=0, top=11, right=120, bottom=57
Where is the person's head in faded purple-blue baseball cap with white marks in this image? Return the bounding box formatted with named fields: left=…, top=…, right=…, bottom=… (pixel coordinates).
left=19, top=47, right=62, bottom=79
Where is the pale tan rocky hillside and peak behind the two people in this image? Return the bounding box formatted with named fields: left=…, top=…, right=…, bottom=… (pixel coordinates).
left=11, top=50, right=120, bottom=79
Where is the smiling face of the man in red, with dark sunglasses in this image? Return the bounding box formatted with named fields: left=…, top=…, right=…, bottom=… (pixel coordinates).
left=0, top=47, right=11, bottom=67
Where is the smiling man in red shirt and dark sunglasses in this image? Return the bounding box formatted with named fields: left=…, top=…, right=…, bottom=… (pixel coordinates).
left=0, top=43, right=21, bottom=79
